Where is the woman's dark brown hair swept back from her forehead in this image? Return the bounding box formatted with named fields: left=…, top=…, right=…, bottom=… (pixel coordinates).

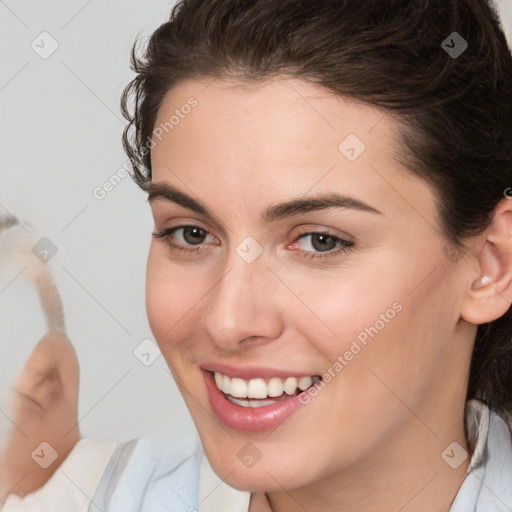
left=122, top=0, right=512, bottom=411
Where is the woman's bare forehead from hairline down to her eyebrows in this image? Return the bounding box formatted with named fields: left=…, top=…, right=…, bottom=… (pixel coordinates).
left=151, top=77, right=434, bottom=226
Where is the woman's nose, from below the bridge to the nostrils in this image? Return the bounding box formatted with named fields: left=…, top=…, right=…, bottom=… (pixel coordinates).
left=202, top=251, right=283, bottom=351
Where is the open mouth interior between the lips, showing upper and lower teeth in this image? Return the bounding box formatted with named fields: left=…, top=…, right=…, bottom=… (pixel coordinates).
left=212, top=372, right=321, bottom=408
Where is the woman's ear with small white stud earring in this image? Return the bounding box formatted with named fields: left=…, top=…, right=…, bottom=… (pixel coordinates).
left=461, top=198, right=512, bottom=325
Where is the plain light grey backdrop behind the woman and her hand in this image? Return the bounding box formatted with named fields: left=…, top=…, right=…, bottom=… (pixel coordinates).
left=0, top=0, right=512, bottom=440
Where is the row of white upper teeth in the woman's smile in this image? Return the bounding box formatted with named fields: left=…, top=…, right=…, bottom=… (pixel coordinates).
left=210, top=372, right=319, bottom=400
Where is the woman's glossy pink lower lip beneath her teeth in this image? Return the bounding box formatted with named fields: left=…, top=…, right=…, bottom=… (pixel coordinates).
left=201, top=370, right=303, bottom=432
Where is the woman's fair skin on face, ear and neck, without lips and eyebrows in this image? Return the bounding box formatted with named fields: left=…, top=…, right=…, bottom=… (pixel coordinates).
left=146, top=76, right=512, bottom=512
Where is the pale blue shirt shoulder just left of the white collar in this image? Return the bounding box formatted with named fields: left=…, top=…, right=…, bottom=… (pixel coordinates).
left=92, top=438, right=203, bottom=512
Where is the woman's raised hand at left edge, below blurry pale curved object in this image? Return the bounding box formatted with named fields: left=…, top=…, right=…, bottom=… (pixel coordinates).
left=0, top=332, right=80, bottom=498
